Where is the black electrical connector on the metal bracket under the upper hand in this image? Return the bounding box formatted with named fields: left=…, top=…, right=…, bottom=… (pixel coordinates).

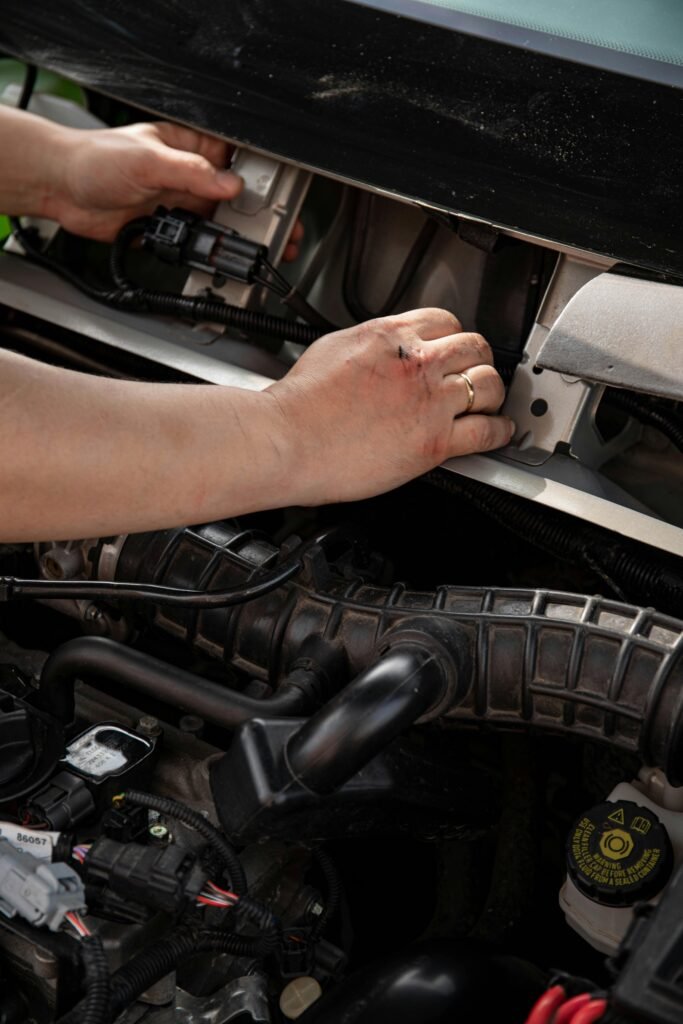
left=142, top=206, right=268, bottom=285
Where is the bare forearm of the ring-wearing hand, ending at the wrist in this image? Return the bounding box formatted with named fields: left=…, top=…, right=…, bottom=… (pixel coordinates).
left=0, top=352, right=293, bottom=542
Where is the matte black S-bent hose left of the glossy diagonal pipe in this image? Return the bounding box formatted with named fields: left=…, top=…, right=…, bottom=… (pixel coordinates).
left=40, top=637, right=319, bottom=729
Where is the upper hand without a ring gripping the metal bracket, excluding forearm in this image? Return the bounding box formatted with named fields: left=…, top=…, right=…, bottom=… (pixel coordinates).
left=49, top=122, right=303, bottom=259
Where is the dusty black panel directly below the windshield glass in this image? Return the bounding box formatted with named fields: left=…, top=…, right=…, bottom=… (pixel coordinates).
left=0, top=0, right=683, bottom=273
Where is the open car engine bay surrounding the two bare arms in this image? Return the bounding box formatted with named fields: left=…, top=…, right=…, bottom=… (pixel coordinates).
left=0, top=90, right=683, bottom=1024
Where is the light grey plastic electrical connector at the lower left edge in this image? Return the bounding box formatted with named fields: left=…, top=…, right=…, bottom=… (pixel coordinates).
left=0, top=839, right=86, bottom=932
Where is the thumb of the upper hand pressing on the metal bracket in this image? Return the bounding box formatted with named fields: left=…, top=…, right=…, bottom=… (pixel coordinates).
left=144, top=145, right=244, bottom=201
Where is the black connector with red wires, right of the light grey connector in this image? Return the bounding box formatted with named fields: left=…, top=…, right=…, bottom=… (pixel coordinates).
left=84, top=839, right=209, bottom=911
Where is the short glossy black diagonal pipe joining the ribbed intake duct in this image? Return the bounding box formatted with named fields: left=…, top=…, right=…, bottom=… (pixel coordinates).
left=287, top=644, right=446, bottom=795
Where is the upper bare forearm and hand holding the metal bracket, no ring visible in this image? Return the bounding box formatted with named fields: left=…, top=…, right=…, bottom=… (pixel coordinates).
left=0, top=104, right=242, bottom=240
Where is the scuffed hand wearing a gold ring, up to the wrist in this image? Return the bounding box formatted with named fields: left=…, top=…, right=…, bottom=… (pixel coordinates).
left=264, top=309, right=514, bottom=505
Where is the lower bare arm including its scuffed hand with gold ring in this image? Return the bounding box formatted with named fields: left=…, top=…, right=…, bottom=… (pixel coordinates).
left=0, top=309, right=512, bottom=541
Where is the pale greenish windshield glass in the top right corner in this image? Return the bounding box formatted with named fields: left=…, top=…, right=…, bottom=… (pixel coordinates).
left=352, top=0, right=683, bottom=85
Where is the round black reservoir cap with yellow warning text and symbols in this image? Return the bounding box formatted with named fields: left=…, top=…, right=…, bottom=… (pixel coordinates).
left=567, top=800, right=673, bottom=906
